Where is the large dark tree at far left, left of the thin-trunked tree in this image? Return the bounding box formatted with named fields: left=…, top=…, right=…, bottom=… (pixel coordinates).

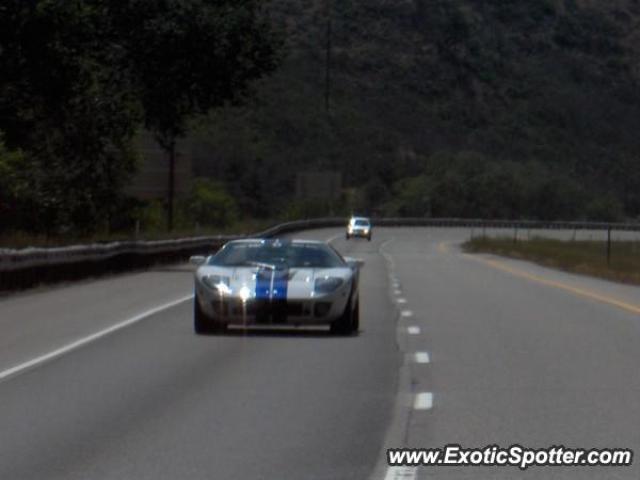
left=0, top=0, right=141, bottom=232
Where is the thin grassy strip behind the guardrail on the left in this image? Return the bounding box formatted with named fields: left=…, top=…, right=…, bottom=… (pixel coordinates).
left=0, top=220, right=282, bottom=249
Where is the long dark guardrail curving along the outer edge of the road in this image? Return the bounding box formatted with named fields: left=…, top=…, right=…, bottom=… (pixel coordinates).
left=0, top=218, right=640, bottom=290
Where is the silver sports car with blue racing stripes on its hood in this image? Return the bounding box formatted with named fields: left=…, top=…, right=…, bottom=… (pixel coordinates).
left=191, top=239, right=363, bottom=335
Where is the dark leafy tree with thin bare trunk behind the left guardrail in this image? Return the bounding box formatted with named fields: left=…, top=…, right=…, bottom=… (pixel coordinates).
left=118, top=0, right=279, bottom=230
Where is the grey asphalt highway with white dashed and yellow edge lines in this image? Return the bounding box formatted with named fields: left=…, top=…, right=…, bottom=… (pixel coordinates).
left=0, top=228, right=640, bottom=480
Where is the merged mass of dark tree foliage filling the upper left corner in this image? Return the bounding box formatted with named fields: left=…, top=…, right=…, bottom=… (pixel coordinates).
left=0, top=0, right=279, bottom=233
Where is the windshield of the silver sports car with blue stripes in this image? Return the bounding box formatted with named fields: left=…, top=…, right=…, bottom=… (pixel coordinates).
left=209, top=242, right=345, bottom=268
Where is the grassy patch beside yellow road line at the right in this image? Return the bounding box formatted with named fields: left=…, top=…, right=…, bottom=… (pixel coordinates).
left=463, top=237, right=640, bottom=285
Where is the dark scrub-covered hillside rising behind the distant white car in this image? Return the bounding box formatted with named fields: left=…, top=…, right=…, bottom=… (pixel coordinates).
left=197, top=0, right=640, bottom=220
